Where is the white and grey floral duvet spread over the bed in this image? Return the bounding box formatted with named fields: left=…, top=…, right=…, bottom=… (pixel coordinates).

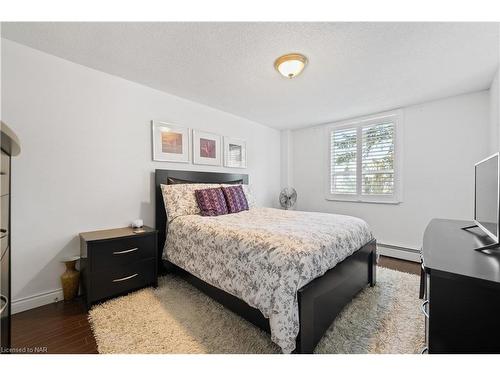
left=163, top=208, right=372, bottom=353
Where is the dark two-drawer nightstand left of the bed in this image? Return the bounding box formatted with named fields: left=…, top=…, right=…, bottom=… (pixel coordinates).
left=80, top=227, right=158, bottom=308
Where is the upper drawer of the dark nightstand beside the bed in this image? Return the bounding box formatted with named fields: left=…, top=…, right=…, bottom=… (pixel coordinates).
left=88, top=235, right=156, bottom=271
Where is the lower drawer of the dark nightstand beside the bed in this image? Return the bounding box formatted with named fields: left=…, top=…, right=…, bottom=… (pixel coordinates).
left=90, top=258, right=156, bottom=301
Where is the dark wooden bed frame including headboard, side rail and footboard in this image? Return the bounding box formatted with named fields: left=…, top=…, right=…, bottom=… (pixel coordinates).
left=155, top=169, right=376, bottom=353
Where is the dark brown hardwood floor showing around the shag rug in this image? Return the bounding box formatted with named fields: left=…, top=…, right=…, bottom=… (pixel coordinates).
left=12, top=257, right=420, bottom=354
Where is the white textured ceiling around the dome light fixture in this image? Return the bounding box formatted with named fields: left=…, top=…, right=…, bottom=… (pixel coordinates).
left=2, top=23, right=500, bottom=129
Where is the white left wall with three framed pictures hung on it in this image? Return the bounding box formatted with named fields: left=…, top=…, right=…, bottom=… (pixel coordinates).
left=2, top=40, right=280, bottom=311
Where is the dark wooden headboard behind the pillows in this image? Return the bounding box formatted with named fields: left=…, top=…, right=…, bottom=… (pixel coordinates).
left=155, top=169, right=248, bottom=273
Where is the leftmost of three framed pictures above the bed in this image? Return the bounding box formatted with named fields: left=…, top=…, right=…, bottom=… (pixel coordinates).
left=151, top=121, right=191, bottom=163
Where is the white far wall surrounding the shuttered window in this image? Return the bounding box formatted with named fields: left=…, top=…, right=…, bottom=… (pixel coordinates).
left=293, top=91, right=490, bottom=249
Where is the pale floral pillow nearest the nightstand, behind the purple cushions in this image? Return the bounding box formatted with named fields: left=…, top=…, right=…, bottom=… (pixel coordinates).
left=161, top=184, right=220, bottom=222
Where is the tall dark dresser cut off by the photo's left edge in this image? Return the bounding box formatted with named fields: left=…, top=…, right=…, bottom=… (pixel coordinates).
left=0, top=122, right=20, bottom=353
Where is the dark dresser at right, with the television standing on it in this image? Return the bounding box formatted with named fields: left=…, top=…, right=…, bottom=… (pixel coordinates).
left=420, top=219, right=500, bottom=353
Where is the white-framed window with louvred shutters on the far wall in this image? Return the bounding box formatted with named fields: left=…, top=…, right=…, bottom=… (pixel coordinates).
left=326, top=112, right=401, bottom=203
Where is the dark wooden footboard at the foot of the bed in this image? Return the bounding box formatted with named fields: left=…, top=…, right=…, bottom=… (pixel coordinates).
left=295, top=240, right=377, bottom=353
